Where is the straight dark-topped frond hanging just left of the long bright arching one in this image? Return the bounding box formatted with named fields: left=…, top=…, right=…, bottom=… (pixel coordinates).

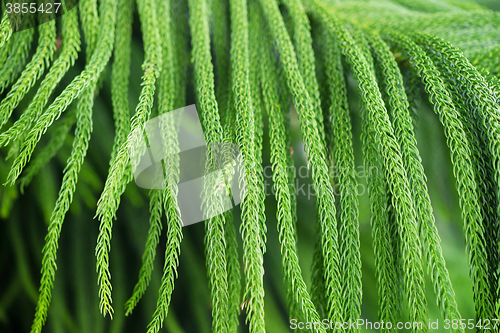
left=324, top=24, right=362, bottom=320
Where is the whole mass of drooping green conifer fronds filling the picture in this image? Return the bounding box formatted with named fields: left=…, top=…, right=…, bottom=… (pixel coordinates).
left=0, top=0, right=500, bottom=333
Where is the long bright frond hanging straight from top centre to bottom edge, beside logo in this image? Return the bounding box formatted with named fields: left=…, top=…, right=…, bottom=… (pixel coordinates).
left=230, top=0, right=265, bottom=332
